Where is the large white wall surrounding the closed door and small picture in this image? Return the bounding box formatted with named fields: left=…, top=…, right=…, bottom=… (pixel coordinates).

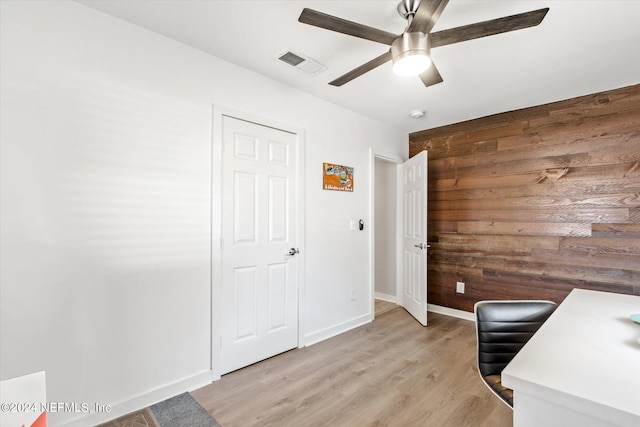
left=0, top=1, right=408, bottom=426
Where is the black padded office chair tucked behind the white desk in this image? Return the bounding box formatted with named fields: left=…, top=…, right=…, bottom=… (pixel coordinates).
left=473, top=301, right=556, bottom=408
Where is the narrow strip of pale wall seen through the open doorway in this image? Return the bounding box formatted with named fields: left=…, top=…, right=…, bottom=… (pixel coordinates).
left=374, top=159, right=398, bottom=301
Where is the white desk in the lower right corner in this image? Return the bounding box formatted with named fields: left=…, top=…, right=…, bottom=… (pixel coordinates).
left=502, top=289, right=640, bottom=427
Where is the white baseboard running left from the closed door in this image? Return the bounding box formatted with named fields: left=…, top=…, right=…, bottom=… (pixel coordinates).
left=63, top=370, right=212, bottom=427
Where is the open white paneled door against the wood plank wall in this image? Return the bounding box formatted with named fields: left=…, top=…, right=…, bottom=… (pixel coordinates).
left=401, top=151, right=428, bottom=326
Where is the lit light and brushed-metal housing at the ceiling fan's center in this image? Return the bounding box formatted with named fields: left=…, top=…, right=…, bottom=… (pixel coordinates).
left=391, top=32, right=431, bottom=76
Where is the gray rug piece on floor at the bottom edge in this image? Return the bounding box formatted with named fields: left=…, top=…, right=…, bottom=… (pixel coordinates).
left=151, top=393, right=221, bottom=427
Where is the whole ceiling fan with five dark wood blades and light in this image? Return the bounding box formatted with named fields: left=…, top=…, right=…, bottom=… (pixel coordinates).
left=298, top=0, right=549, bottom=86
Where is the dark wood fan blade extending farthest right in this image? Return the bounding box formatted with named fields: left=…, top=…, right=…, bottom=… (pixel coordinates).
left=430, top=7, right=549, bottom=48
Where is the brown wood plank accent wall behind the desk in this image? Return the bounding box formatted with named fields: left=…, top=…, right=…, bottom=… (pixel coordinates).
left=409, top=85, right=640, bottom=311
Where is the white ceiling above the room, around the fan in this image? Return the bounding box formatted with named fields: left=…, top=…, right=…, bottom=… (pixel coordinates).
left=78, top=0, right=640, bottom=132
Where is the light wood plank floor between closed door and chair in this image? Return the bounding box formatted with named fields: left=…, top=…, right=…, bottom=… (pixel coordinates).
left=191, top=306, right=512, bottom=427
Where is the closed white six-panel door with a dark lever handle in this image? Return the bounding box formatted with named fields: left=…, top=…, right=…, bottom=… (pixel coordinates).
left=221, top=116, right=298, bottom=374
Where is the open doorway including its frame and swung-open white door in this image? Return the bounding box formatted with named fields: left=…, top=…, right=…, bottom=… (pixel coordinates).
left=370, top=150, right=429, bottom=326
